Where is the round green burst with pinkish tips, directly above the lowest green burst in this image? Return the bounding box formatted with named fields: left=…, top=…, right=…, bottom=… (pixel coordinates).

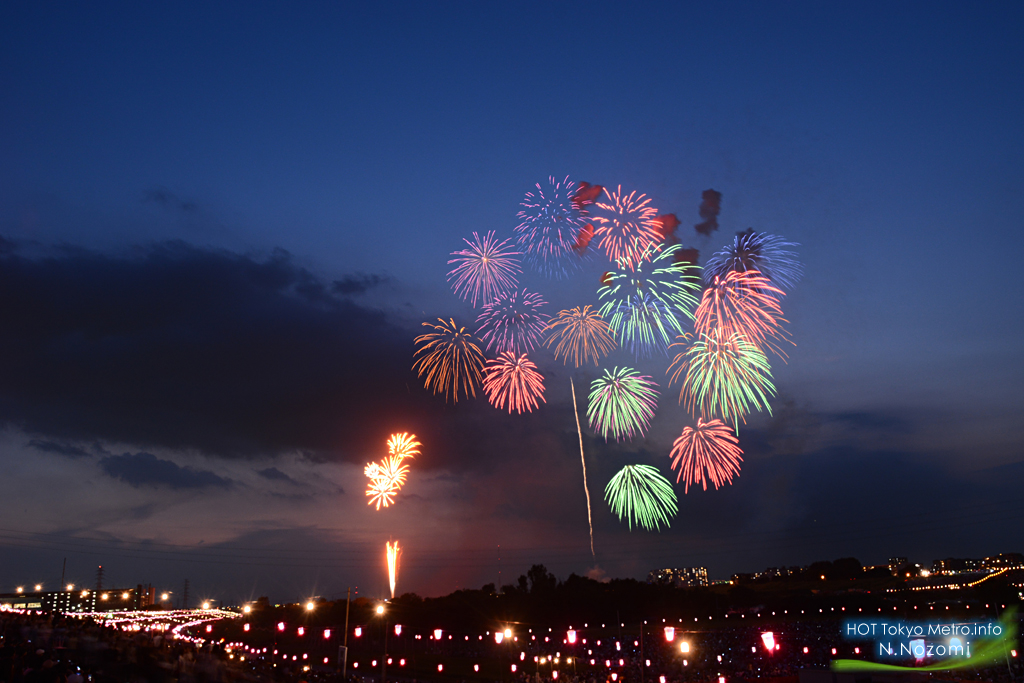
left=587, top=368, right=657, bottom=440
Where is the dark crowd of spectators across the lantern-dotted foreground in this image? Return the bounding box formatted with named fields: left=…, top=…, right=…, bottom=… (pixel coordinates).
left=0, top=612, right=1024, bottom=683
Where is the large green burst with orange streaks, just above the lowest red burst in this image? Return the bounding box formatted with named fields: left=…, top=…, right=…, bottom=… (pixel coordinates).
left=668, top=329, right=775, bottom=426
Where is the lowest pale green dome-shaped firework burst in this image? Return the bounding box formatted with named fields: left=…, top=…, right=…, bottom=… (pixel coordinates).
left=604, top=465, right=679, bottom=530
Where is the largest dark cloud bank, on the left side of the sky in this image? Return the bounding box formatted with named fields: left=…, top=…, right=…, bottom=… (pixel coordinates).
left=0, top=242, right=425, bottom=461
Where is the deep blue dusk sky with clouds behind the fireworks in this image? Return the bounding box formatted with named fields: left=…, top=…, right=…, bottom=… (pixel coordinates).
left=0, top=2, right=1024, bottom=602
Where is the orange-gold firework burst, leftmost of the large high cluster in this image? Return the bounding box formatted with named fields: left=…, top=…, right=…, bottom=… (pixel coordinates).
left=413, top=318, right=484, bottom=402
